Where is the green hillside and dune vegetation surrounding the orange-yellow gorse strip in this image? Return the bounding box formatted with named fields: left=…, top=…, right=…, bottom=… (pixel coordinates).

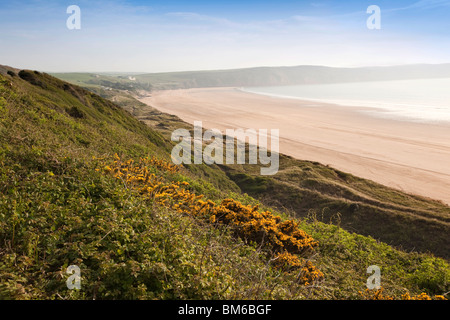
left=0, top=69, right=450, bottom=299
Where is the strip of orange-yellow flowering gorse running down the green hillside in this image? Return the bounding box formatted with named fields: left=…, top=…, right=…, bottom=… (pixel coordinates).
left=102, top=154, right=323, bottom=284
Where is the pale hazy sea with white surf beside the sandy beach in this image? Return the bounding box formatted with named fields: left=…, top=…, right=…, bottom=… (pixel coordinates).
left=242, top=78, right=450, bottom=124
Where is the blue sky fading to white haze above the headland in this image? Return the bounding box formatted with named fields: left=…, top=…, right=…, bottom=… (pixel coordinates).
left=0, top=0, right=450, bottom=72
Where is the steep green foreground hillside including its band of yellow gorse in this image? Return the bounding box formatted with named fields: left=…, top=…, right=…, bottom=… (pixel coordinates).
left=0, top=70, right=450, bottom=299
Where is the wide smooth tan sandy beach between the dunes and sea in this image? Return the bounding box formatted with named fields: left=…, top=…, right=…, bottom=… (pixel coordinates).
left=140, top=88, right=450, bottom=204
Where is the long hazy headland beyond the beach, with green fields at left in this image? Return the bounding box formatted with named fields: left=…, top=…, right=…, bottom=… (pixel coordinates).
left=52, top=64, right=450, bottom=92
